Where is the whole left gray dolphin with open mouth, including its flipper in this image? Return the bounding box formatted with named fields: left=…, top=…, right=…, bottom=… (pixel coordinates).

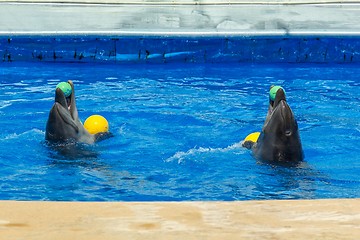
left=45, top=81, right=110, bottom=144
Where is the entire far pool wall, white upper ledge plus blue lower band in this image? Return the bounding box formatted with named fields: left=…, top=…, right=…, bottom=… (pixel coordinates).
left=0, top=0, right=360, bottom=63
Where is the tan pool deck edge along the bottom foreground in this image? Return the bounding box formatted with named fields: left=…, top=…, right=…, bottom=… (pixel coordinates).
left=0, top=199, right=360, bottom=240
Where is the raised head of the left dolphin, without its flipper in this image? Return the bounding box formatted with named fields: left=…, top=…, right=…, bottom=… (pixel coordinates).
left=45, top=81, right=81, bottom=141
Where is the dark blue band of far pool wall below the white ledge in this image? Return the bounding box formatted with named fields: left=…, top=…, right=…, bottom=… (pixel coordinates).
left=0, top=37, right=360, bottom=63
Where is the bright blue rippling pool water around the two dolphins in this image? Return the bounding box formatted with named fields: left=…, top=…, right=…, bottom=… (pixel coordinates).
left=0, top=62, right=360, bottom=201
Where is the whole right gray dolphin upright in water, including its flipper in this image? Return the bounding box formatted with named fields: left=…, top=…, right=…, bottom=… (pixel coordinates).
left=243, top=88, right=304, bottom=162
